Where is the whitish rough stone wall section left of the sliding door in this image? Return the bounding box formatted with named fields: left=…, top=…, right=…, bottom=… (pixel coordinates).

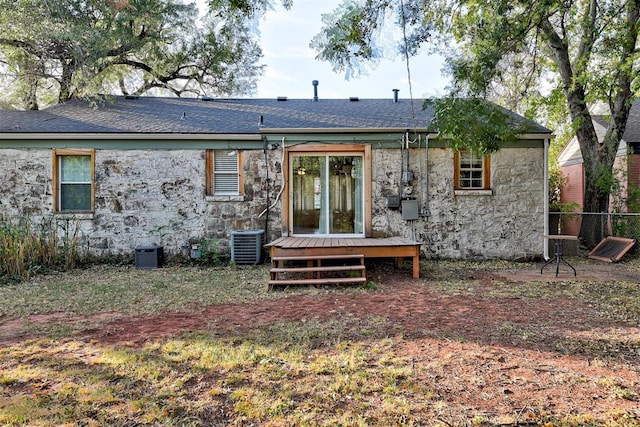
left=0, top=149, right=280, bottom=256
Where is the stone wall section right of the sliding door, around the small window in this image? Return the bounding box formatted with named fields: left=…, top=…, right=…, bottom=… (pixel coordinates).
left=372, top=148, right=545, bottom=259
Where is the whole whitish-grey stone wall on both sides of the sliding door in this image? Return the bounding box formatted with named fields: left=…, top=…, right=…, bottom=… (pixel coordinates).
left=0, top=148, right=544, bottom=259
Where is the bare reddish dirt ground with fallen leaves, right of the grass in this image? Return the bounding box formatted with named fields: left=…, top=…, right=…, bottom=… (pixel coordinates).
left=2, top=262, right=640, bottom=425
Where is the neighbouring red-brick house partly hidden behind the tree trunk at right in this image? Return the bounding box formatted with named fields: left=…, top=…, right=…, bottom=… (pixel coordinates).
left=558, top=100, right=640, bottom=236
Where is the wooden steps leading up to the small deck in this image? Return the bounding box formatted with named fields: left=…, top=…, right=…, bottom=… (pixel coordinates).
left=269, top=254, right=367, bottom=287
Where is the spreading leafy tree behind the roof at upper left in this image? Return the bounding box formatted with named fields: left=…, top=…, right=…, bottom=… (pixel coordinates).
left=0, top=0, right=262, bottom=109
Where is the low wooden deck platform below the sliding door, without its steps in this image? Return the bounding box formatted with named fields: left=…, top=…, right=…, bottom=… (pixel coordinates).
left=266, top=237, right=420, bottom=279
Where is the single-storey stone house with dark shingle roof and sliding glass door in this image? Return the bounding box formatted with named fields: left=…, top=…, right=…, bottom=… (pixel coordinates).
left=0, top=88, right=551, bottom=270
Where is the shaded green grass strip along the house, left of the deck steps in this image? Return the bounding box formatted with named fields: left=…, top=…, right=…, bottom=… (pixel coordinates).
left=0, top=265, right=378, bottom=318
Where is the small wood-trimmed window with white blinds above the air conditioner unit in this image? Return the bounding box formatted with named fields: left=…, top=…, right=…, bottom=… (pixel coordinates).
left=207, top=150, right=240, bottom=196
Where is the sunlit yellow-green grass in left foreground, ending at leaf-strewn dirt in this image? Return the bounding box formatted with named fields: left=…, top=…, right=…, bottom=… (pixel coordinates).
left=0, top=334, right=424, bottom=426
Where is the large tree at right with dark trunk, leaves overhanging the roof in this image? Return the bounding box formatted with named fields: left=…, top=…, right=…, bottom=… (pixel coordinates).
left=312, top=0, right=640, bottom=244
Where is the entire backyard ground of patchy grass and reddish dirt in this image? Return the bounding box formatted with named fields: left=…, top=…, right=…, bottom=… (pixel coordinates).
left=0, top=259, right=640, bottom=426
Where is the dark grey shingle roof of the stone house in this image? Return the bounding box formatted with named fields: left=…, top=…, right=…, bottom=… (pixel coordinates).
left=0, top=97, right=551, bottom=134
